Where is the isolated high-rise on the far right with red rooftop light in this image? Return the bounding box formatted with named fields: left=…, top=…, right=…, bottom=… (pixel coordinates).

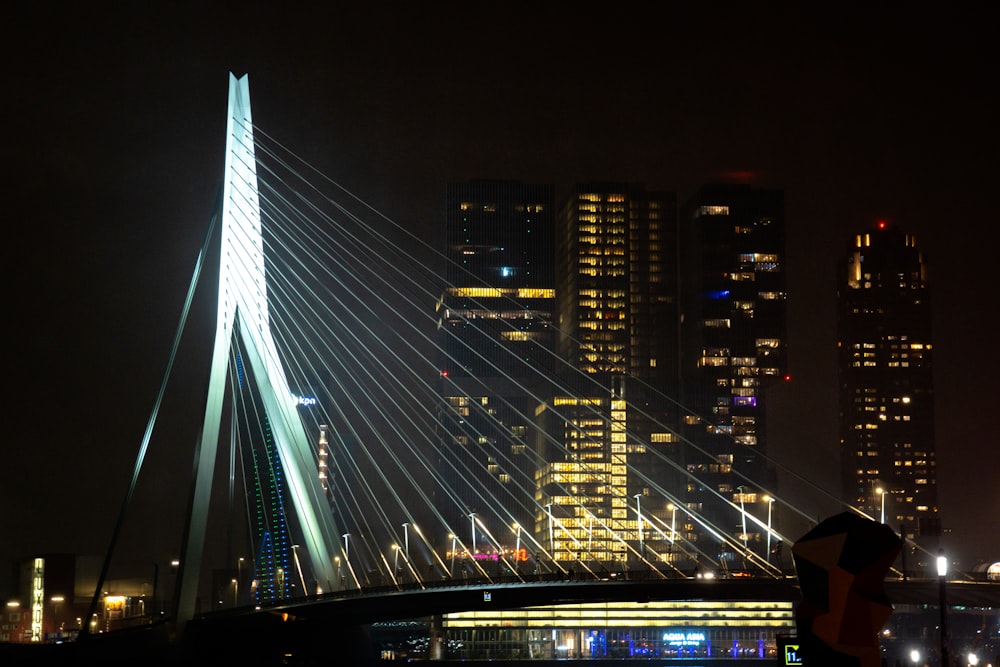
left=837, top=222, right=940, bottom=537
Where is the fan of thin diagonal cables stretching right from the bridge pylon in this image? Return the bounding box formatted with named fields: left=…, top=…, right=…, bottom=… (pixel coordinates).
left=199, top=116, right=880, bottom=592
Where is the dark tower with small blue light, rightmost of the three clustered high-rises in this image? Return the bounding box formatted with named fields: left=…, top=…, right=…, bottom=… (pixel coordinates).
left=680, top=184, right=787, bottom=568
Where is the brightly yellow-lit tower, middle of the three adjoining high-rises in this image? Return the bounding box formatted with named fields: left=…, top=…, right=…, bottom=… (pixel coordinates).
left=535, top=183, right=678, bottom=568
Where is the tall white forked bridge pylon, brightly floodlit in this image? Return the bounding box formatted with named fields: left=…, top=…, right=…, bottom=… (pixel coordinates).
left=176, top=73, right=340, bottom=625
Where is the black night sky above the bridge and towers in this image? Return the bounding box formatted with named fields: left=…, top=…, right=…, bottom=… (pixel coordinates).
left=0, top=2, right=1000, bottom=592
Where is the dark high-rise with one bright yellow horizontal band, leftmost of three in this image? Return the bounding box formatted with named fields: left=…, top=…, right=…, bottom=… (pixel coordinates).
left=436, top=180, right=554, bottom=557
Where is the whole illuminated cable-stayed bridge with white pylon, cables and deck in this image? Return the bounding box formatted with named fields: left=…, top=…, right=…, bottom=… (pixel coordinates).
left=64, top=77, right=1000, bottom=664
